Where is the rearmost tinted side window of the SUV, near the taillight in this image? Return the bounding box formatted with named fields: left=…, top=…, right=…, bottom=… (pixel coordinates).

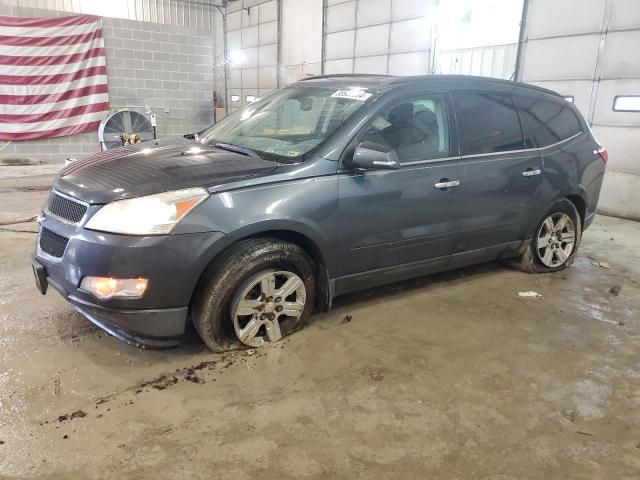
left=513, top=95, right=582, bottom=148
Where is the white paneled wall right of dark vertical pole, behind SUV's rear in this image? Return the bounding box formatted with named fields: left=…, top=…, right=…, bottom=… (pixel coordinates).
left=520, top=0, right=640, bottom=219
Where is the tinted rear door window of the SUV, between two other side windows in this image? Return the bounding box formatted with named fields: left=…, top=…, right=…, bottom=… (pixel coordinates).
left=453, top=92, right=523, bottom=155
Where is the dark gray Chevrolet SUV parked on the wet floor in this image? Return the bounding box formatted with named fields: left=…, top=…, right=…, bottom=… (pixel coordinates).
left=33, top=75, right=607, bottom=351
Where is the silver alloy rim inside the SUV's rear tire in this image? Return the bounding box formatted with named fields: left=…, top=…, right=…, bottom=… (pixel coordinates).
left=536, top=212, right=576, bottom=268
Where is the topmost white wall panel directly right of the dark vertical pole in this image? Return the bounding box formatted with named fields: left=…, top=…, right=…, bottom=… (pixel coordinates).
left=529, top=0, right=604, bottom=39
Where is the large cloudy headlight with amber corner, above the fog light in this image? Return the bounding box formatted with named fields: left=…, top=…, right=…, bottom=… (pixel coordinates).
left=85, top=188, right=209, bottom=235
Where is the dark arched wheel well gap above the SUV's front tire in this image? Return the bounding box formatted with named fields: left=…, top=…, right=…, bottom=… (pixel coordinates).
left=194, top=230, right=332, bottom=311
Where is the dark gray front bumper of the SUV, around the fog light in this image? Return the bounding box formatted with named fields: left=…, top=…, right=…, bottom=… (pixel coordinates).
left=34, top=212, right=225, bottom=348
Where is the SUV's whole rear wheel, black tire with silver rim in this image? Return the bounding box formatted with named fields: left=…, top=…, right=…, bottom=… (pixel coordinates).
left=516, top=198, right=582, bottom=273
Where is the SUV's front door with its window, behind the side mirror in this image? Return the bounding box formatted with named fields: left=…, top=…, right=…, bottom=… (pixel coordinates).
left=336, top=93, right=464, bottom=292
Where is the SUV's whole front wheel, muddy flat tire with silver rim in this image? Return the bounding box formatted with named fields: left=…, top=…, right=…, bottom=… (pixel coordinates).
left=191, top=238, right=316, bottom=352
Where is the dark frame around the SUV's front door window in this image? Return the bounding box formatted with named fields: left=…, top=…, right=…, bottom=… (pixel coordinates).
left=339, top=88, right=460, bottom=169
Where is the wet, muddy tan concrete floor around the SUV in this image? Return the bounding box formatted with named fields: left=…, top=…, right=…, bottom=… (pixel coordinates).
left=0, top=171, right=640, bottom=480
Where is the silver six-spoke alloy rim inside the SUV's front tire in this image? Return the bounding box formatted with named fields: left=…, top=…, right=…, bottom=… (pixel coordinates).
left=231, top=271, right=307, bottom=347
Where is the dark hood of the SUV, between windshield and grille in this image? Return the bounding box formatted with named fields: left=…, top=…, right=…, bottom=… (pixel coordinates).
left=54, top=141, right=278, bottom=204
